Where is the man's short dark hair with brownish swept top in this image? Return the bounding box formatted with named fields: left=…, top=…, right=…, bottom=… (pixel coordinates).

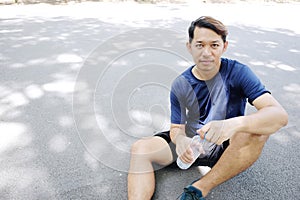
left=188, top=16, right=228, bottom=43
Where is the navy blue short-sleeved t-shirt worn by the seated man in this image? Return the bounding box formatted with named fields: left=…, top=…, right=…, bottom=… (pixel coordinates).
left=170, top=58, right=269, bottom=136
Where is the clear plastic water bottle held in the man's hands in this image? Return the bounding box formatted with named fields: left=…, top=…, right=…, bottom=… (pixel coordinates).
left=176, top=135, right=205, bottom=169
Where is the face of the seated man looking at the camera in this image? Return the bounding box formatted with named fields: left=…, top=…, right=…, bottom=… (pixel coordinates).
left=187, top=27, right=227, bottom=72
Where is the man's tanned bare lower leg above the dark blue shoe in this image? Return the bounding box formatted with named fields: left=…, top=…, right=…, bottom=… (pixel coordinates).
left=193, top=133, right=268, bottom=197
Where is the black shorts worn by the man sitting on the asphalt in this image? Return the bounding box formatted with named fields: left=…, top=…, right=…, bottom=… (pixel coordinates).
left=154, top=131, right=229, bottom=167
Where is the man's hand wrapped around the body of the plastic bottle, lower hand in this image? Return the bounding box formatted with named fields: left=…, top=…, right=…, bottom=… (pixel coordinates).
left=176, top=135, right=194, bottom=163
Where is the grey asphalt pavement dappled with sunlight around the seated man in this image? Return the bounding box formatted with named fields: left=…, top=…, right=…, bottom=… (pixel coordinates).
left=0, top=1, right=300, bottom=200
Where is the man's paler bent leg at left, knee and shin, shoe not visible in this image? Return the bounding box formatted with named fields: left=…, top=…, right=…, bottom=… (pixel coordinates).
left=128, top=136, right=173, bottom=200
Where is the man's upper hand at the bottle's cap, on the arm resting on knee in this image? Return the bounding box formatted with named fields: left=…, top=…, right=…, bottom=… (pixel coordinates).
left=197, top=120, right=236, bottom=145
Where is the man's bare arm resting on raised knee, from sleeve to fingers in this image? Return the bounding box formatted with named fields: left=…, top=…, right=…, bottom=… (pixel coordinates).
left=197, top=93, right=288, bottom=144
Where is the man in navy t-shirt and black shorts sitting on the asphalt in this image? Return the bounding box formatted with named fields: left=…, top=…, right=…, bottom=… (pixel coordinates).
left=128, top=16, right=288, bottom=200
